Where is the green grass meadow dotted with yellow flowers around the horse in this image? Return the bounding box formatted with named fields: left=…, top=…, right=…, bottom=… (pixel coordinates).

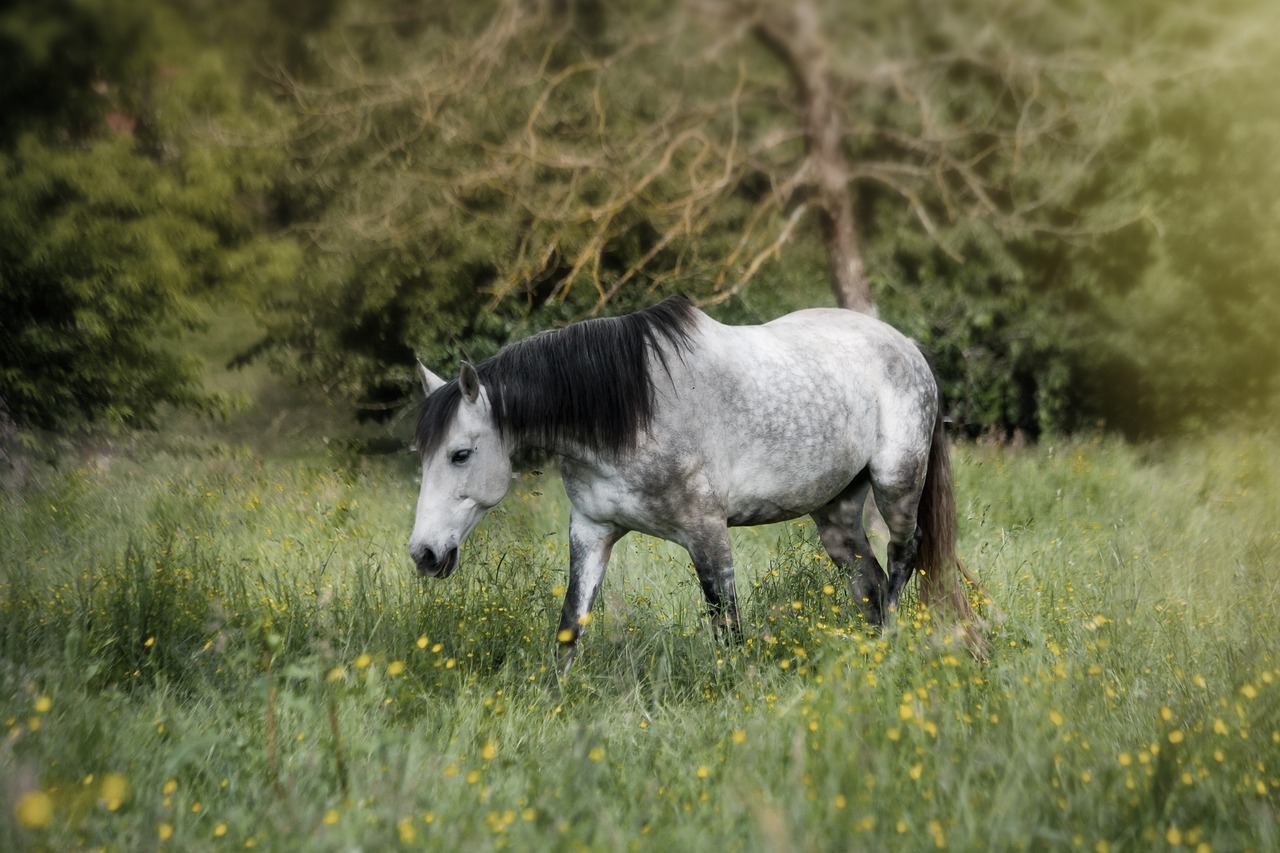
left=0, top=422, right=1280, bottom=852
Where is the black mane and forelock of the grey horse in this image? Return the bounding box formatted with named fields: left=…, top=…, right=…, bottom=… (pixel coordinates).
left=415, top=297, right=698, bottom=457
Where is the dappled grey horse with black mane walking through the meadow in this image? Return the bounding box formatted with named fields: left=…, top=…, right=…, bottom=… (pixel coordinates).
left=410, top=297, right=975, bottom=670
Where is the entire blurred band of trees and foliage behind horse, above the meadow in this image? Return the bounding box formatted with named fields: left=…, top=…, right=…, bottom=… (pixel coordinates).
left=0, top=0, right=1280, bottom=435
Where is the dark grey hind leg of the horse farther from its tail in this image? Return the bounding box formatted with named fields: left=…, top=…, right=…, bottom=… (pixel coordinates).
left=810, top=471, right=888, bottom=625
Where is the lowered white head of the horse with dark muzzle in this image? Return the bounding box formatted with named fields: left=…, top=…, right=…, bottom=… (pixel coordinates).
left=408, top=361, right=511, bottom=578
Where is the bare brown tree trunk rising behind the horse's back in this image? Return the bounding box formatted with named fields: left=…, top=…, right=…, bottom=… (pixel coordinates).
left=755, top=0, right=876, bottom=314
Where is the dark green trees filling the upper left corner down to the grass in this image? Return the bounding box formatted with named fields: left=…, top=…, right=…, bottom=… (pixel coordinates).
left=0, top=3, right=294, bottom=432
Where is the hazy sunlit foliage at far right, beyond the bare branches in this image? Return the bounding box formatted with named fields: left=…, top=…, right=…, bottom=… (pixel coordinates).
left=1096, top=40, right=1280, bottom=432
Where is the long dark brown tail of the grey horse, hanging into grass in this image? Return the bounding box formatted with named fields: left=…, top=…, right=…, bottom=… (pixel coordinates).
left=918, top=400, right=986, bottom=656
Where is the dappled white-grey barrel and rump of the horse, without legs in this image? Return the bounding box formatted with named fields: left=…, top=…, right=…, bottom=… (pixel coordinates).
left=645, top=302, right=937, bottom=524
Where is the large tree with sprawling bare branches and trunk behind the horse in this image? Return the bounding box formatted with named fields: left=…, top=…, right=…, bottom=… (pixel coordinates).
left=268, top=0, right=1263, bottom=430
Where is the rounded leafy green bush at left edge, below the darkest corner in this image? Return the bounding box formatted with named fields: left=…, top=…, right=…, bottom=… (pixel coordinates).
left=0, top=136, right=218, bottom=429
